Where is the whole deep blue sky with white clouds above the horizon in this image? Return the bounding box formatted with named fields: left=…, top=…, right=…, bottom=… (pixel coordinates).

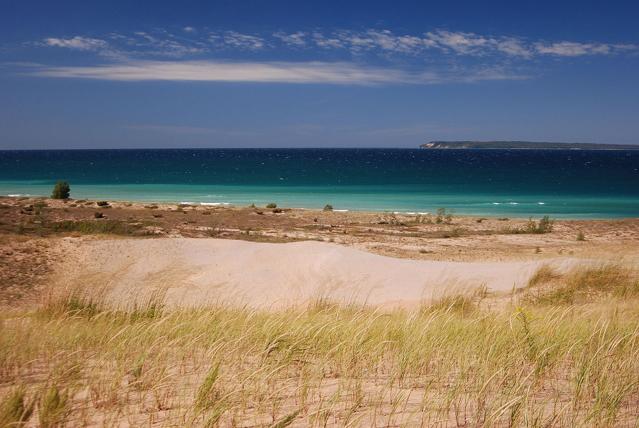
left=0, top=0, right=639, bottom=149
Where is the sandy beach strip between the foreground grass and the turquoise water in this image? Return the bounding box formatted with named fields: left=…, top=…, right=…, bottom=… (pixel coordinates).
left=2, top=198, right=639, bottom=308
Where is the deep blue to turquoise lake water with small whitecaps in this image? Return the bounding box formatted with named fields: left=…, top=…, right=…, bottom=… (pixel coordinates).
left=0, top=149, right=639, bottom=218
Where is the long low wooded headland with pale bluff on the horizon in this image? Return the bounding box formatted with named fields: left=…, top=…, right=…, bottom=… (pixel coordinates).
left=419, top=141, right=639, bottom=150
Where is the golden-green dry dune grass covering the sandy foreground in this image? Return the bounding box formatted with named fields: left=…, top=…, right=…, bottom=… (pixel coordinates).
left=0, top=266, right=639, bottom=427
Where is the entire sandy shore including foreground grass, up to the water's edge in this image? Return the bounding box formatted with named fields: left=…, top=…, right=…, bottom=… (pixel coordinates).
left=0, top=197, right=639, bottom=427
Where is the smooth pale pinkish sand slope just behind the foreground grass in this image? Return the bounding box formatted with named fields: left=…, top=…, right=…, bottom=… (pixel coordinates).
left=60, top=238, right=577, bottom=308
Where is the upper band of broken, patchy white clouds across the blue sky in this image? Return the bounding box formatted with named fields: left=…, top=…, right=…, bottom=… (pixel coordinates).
left=40, top=26, right=639, bottom=60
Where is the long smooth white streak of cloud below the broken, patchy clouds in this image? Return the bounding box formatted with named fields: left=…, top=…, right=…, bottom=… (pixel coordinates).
left=26, top=60, right=526, bottom=85
